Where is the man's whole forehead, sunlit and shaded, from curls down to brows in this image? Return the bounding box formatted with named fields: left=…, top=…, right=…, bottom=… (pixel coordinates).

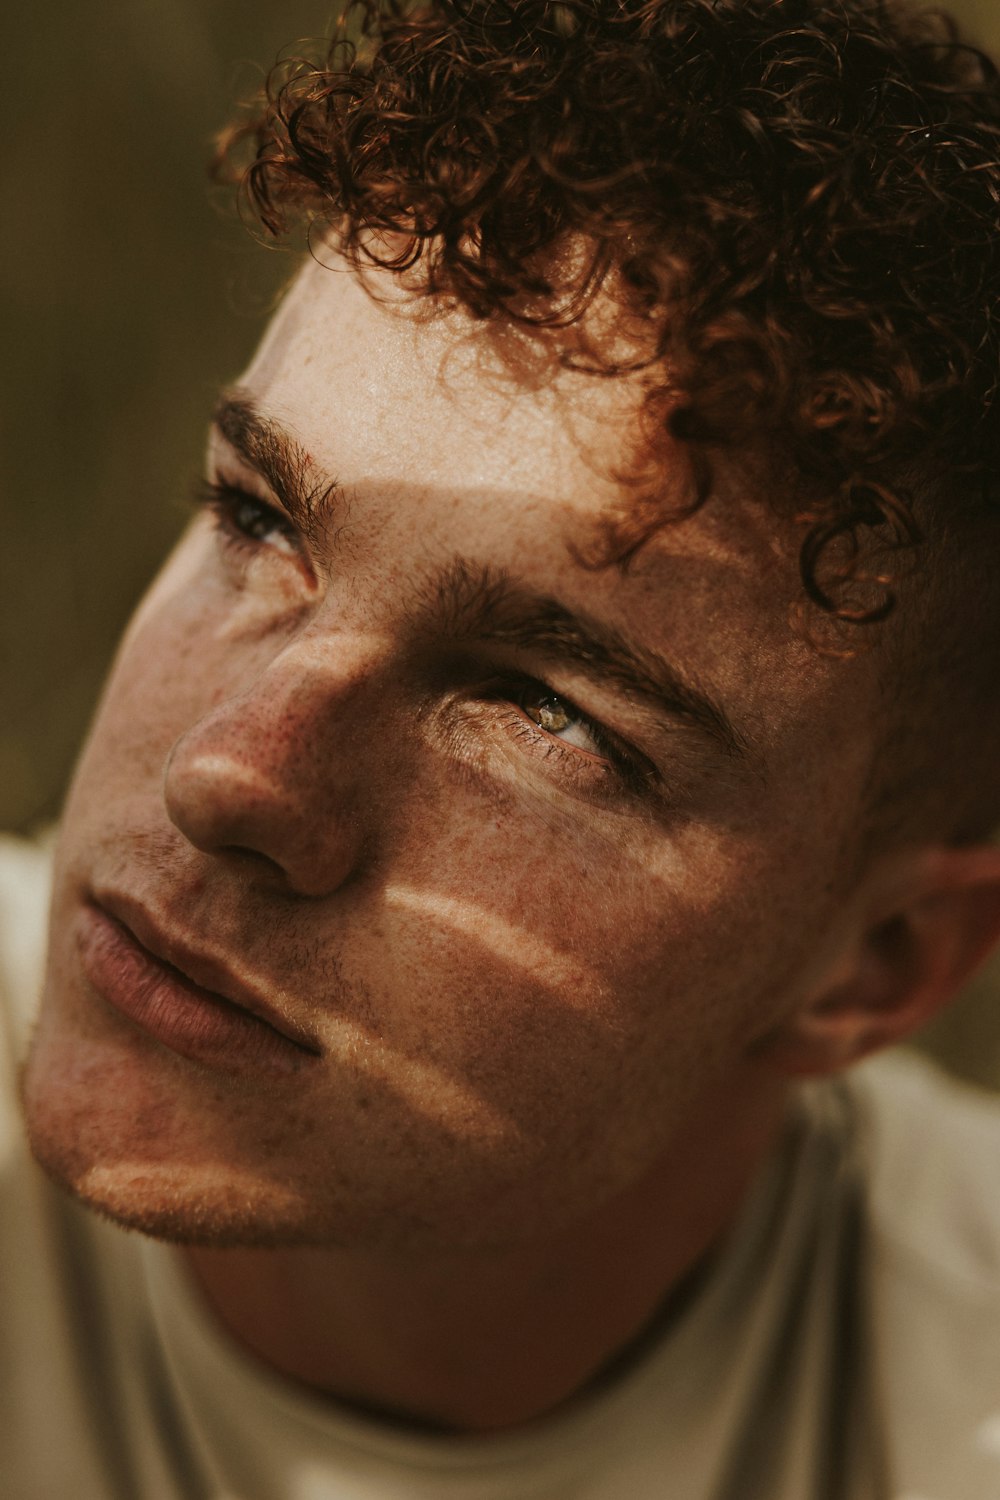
left=244, top=263, right=871, bottom=762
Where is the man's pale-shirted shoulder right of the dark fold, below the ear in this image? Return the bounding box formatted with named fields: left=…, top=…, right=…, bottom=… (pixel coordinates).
left=846, top=1053, right=1000, bottom=1500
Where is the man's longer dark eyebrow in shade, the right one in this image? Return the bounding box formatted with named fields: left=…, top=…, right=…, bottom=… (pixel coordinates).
left=421, top=558, right=750, bottom=761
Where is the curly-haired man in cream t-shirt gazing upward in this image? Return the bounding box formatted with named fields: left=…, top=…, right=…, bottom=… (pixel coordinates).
left=1, top=0, right=1000, bottom=1500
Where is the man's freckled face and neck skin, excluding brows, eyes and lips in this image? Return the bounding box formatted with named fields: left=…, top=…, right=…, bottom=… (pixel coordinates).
left=22, top=264, right=917, bottom=1431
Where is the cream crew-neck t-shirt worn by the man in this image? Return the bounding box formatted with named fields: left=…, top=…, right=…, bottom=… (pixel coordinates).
left=0, top=840, right=1000, bottom=1500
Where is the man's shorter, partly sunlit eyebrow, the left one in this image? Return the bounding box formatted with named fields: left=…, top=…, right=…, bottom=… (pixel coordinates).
left=211, top=389, right=343, bottom=536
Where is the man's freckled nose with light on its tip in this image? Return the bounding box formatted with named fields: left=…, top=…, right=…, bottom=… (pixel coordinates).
left=163, top=639, right=374, bottom=897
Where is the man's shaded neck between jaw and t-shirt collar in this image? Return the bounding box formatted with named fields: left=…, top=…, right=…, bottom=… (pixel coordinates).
left=183, top=1068, right=786, bottom=1434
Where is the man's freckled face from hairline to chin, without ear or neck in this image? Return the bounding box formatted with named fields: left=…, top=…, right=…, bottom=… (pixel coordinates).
left=24, top=264, right=873, bottom=1245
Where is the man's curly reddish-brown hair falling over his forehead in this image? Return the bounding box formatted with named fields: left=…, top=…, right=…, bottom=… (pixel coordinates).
left=223, top=0, right=1000, bottom=621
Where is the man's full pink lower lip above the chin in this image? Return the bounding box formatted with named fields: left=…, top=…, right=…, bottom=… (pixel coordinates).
left=76, top=906, right=313, bottom=1073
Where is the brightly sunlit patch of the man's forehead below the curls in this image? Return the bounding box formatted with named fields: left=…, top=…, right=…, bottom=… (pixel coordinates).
left=247, top=261, right=650, bottom=501
